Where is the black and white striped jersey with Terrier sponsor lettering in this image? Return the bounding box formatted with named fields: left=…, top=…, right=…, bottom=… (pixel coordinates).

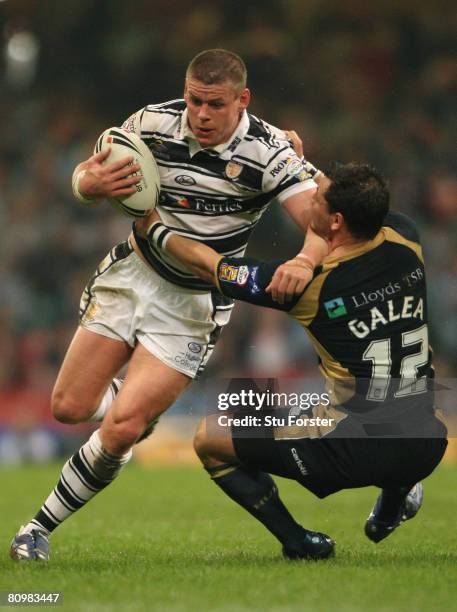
left=122, top=100, right=318, bottom=291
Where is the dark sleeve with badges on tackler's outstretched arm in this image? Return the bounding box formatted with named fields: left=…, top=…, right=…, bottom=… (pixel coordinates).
left=216, top=257, right=301, bottom=312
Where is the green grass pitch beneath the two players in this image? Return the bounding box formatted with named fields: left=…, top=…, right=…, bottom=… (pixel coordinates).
left=0, top=465, right=457, bottom=612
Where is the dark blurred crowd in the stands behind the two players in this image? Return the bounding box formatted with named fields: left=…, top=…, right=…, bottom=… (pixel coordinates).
left=0, top=0, right=457, bottom=463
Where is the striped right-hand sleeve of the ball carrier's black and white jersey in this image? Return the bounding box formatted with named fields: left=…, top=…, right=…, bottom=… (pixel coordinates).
left=262, top=139, right=319, bottom=204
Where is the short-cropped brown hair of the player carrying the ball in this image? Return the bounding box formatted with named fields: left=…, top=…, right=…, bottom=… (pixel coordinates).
left=186, top=49, right=247, bottom=94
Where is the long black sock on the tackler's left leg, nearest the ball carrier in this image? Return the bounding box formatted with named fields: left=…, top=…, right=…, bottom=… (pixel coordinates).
left=206, top=464, right=306, bottom=547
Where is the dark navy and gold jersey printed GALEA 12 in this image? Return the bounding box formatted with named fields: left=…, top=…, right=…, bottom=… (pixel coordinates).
left=217, top=212, right=433, bottom=430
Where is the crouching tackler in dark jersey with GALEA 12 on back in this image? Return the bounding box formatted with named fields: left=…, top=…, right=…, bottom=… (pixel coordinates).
left=144, top=164, right=447, bottom=559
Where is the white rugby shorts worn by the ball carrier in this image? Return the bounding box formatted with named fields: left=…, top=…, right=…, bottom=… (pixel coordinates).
left=79, top=242, right=233, bottom=378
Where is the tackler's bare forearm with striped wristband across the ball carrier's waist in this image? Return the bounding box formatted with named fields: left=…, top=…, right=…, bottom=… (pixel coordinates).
left=148, top=223, right=222, bottom=285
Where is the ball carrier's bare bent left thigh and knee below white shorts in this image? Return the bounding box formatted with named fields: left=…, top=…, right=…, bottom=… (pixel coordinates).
left=51, top=327, right=132, bottom=423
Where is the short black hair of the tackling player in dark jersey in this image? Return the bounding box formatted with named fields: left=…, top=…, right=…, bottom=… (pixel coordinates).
left=325, top=162, right=389, bottom=240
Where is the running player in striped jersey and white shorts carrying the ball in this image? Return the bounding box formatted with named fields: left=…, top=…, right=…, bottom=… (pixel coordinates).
left=11, top=49, right=326, bottom=560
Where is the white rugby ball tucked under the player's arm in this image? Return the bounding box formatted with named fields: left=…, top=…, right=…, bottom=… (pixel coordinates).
left=94, top=127, right=160, bottom=217
